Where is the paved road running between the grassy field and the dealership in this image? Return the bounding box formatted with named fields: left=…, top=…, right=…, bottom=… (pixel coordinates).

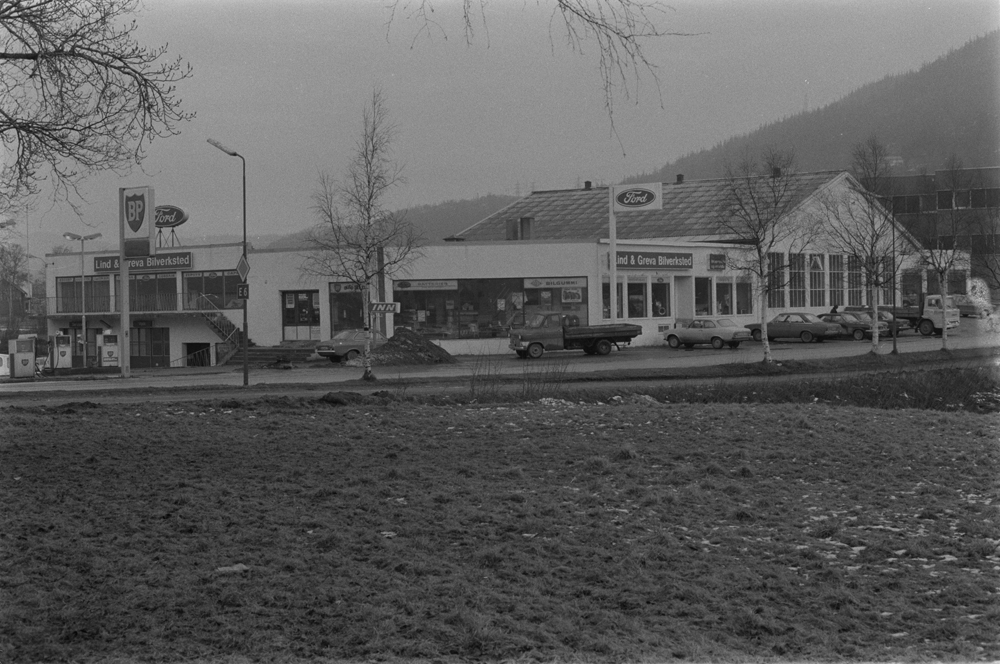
left=0, top=318, right=1000, bottom=406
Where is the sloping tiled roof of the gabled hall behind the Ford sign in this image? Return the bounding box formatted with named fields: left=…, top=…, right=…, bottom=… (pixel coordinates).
left=456, top=171, right=843, bottom=242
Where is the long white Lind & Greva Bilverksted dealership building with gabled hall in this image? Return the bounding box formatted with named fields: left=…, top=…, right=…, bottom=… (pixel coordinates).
left=46, top=171, right=965, bottom=367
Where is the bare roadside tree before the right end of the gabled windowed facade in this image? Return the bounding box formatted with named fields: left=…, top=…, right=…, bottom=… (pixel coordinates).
left=821, top=136, right=911, bottom=353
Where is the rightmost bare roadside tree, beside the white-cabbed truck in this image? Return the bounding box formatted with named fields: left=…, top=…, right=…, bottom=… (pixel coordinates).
left=910, top=155, right=977, bottom=350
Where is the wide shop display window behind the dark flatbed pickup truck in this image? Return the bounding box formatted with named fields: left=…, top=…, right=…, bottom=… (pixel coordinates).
left=393, top=277, right=588, bottom=339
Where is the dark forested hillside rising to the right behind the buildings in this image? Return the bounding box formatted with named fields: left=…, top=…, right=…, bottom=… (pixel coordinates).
left=628, top=31, right=1000, bottom=182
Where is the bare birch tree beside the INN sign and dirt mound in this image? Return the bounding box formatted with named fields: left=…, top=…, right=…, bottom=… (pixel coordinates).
left=303, top=90, right=420, bottom=380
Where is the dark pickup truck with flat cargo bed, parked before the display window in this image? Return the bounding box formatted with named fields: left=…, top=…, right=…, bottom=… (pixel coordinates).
left=509, top=313, right=642, bottom=359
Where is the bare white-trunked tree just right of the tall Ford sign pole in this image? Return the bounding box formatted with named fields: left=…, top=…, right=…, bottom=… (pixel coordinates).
left=719, top=147, right=812, bottom=362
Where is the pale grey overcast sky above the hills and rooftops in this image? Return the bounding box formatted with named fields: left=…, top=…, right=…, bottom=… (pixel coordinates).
left=13, top=0, right=1000, bottom=255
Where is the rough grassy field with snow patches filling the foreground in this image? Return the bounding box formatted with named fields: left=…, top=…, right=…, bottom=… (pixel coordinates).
left=0, top=372, right=1000, bottom=662
